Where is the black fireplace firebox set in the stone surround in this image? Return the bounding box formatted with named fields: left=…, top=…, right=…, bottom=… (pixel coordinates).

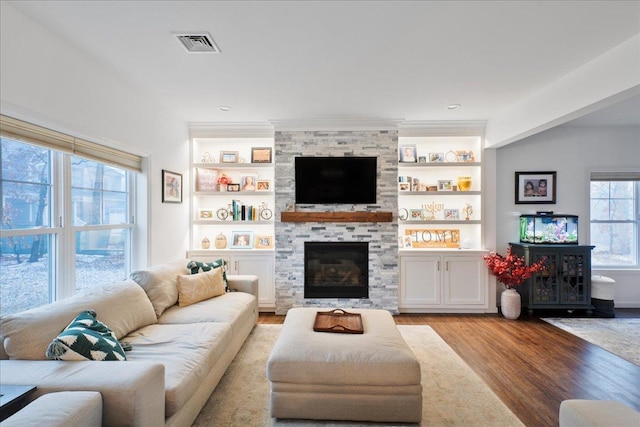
left=304, top=242, right=369, bottom=298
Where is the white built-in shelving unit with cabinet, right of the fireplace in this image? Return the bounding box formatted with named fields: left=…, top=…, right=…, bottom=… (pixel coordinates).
left=398, top=132, right=489, bottom=313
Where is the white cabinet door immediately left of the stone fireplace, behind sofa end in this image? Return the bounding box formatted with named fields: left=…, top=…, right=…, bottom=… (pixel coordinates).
left=230, top=254, right=276, bottom=308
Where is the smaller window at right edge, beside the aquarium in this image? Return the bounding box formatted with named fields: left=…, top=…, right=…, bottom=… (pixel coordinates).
left=590, top=172, right=640, bottom=268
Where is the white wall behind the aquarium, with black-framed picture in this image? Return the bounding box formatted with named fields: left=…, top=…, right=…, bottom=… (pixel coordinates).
left=496, top=126, right=640, bottom=307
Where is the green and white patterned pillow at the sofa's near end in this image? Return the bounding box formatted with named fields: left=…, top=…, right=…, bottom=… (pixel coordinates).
left=46, top=310, right=127, bottom=360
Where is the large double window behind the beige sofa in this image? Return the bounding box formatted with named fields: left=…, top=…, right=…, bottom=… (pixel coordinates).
left=0, top=116, right=141, bottom=315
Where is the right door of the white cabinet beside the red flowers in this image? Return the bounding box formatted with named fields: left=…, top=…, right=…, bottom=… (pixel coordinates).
left=443, top=256, right=487, bottom=306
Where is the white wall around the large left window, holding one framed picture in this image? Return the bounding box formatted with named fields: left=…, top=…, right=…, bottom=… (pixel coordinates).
left=0, top=2, right=189, bottom=267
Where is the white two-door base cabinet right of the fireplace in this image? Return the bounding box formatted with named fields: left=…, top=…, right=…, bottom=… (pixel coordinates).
left=398, top=249, right=489, bottom=313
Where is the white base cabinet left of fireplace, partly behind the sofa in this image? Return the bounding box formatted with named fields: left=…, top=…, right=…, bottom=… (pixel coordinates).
left=187, top=249, right=275, bottom=311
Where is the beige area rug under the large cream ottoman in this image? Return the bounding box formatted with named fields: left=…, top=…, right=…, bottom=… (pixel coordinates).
left=193, top=325, right=523, bottom=427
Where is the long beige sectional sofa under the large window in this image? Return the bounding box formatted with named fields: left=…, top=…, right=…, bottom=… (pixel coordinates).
left=0, top=259, right=258, bottom=427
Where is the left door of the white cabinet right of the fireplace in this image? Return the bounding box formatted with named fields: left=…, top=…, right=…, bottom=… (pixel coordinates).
left=400, top=255, right=442, bottom=308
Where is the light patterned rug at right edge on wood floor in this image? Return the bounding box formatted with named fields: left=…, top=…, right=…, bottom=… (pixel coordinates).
left=542, top=317, right=640, bottom=366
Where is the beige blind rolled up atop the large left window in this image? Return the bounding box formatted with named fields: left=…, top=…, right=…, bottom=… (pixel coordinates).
left=0, top=115, right=142, bottom=172
